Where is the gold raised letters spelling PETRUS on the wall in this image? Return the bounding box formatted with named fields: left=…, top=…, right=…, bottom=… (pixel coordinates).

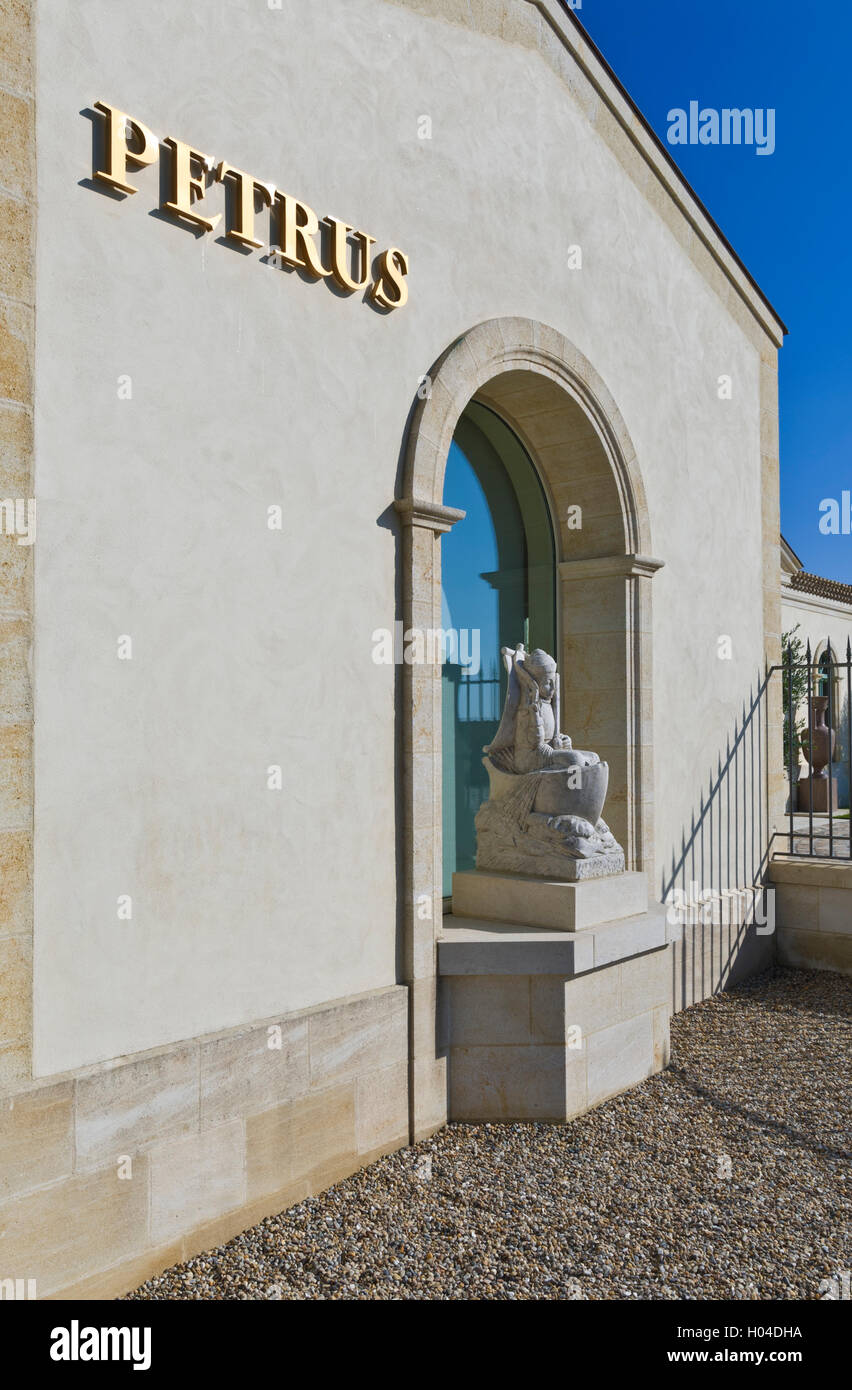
left=93, top=101, right=409, bottom=309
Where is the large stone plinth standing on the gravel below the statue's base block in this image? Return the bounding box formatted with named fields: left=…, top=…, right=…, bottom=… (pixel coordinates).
left=438, top=908, right=671, bottom=1123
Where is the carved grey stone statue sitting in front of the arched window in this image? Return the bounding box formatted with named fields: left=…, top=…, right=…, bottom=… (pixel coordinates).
left=475, top=645, right=624, bottom=880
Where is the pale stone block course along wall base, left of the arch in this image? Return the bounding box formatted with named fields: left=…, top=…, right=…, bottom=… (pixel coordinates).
left=0, top=986, right=409, bottom=1298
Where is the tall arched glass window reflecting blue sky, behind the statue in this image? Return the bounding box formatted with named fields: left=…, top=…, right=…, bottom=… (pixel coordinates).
left=441, top=403, right=557, bottom=898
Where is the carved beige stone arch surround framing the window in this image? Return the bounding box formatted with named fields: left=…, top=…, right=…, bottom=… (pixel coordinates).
left=395, top=318, right=663, bottom=1138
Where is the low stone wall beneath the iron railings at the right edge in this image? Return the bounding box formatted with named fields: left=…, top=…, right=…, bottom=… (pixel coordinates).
left=770, top=859, right=852, bottom=974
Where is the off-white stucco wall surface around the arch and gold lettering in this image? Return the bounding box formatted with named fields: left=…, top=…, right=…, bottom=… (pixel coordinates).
left=29, top=0, right=762, bottom=1073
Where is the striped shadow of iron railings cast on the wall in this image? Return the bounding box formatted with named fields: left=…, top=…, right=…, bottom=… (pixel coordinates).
left=662, top=674, right=776, bottom=1012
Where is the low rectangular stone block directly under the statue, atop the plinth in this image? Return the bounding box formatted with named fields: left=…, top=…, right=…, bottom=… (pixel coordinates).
left=453, top=860, right=648, bottom=931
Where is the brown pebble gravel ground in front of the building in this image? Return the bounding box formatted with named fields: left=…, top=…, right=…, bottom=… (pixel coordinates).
left=126, top=969, right=852, bottom=1300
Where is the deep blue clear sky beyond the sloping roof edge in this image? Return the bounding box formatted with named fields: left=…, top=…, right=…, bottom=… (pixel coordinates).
left=577, top=0, right=852, bottom=584
